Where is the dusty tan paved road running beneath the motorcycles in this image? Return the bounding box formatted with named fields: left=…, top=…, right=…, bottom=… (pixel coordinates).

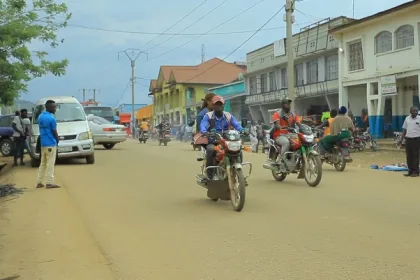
left=0, top=141, right=420, bottom=280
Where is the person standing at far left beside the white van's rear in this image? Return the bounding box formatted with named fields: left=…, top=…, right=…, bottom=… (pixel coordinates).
left=12, top=109, right=28, bottom=166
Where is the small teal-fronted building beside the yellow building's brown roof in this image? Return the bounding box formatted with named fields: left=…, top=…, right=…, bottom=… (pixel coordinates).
left=209, top=80, right=249, bottom=120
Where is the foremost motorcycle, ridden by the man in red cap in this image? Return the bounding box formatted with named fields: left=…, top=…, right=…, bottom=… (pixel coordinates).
left=196, top=118, right=252, bottom=212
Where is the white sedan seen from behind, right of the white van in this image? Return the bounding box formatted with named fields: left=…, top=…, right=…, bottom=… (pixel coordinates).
left=88, top=115, right=128, bottom=150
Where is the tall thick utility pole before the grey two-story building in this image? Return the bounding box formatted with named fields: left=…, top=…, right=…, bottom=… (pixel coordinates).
left=285, top=0, right=295, bottom=112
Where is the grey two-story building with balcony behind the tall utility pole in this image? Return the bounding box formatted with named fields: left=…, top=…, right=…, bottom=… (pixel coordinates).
left=246, top=17, right=352, bottom=123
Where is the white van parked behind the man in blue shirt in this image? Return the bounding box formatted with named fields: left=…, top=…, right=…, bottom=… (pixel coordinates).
left=30, top=96, right=95, bottom=167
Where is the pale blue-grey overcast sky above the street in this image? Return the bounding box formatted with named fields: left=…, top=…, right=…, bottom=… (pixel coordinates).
left=21, top=0, right=408, bottom=106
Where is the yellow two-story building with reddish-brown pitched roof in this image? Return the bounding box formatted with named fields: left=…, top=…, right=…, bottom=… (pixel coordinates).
left=149, top=58, right=246, bottom=124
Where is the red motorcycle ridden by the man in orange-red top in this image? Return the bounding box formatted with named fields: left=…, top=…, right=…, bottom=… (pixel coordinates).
left=263, top=124, right=322, bottom=187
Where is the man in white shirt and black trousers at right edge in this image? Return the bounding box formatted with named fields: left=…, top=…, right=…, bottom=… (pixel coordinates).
left=398, top=106, right=420, bottom=177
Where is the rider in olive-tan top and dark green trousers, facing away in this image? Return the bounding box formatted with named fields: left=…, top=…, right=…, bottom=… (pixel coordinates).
left=321, top=106, right=355, bottom=156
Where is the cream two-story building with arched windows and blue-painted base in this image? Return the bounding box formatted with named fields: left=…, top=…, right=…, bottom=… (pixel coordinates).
left=332, top=1, right=420, bottom=137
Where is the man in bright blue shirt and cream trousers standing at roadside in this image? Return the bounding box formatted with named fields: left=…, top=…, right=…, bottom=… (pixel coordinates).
left=36, top=100, right=60, bottom=189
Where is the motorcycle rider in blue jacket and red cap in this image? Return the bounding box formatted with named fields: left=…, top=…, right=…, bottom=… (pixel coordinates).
left=200, top=96, right=244, bottom=179
